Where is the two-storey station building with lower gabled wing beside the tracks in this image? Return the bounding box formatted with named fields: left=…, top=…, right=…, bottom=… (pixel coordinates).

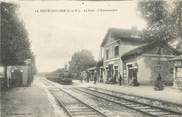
left=101, top=28, right=179, bottom=84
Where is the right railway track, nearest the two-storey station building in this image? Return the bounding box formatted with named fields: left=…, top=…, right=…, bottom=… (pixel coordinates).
left=74, top=88, right=182, bottom=117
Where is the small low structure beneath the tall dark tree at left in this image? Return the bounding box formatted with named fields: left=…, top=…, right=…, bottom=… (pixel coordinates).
left=0, top=59, right=35, bottom=88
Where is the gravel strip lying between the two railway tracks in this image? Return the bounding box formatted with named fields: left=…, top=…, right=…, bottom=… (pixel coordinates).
left=69, top=90, right=150, bottom=117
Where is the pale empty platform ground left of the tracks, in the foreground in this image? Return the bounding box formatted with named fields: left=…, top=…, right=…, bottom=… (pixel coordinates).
left=0, top=78, right=64, bottom=117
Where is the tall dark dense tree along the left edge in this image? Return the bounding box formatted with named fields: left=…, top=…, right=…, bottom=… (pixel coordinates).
left=0, top=2, right=32, bottom=78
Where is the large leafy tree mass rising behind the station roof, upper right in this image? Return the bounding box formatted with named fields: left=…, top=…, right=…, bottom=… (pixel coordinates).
left=138, top=0, right=182, bottom=41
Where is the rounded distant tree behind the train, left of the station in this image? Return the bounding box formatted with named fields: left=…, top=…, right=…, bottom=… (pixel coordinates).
left=69, top=50, right=96, bottom=75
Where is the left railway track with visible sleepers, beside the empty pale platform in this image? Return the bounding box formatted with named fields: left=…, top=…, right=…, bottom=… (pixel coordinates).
left=44, top=78, right=107, bottom=117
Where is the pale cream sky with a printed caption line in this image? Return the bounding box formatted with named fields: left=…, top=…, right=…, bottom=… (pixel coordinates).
left=14, top=1, right=146, bottom=72
